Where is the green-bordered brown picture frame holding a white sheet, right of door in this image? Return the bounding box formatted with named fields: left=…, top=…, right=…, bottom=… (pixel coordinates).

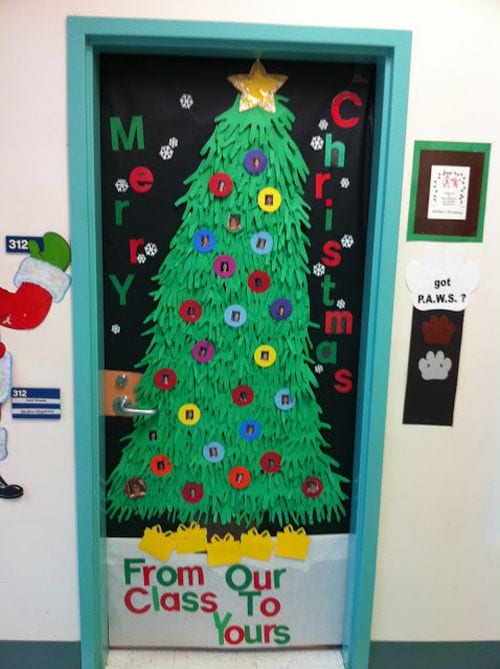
left=407, top=141, right=491, bottom=242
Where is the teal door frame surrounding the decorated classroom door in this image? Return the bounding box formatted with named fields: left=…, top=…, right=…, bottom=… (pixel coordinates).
left=67, top=17, right=411, bottom=669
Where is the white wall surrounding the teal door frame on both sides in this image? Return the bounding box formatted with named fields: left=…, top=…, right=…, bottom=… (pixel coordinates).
left=0, top=0, right=500, bottom=640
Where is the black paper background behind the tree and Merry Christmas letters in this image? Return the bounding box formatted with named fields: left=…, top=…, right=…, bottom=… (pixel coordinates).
left=100, top=55, right=375, bottom=536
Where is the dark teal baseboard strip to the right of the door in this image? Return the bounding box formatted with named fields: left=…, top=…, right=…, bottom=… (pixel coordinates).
left=368, top=641, right=500, bottom=669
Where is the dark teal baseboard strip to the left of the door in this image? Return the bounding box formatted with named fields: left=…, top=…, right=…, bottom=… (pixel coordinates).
left=0, top=641, right=81, bottom=669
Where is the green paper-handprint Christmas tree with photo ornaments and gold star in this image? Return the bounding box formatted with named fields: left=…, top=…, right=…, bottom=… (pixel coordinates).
left=108, top=61, right=346, bottom=525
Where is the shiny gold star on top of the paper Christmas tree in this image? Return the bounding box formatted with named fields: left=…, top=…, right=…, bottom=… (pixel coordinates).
left=228, top=60, right=288, bottom=114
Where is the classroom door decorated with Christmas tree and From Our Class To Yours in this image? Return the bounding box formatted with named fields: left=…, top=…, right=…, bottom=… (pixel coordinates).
left=100, top=55, right=375, bottom=648
